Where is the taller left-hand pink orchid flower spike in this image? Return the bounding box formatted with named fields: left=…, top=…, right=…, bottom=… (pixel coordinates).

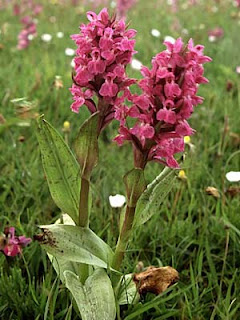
left=70, top=9, right=136, bottom=132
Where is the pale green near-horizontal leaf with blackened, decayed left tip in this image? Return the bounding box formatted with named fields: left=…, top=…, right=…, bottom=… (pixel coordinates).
left=38, top=224, right=113, bottom=268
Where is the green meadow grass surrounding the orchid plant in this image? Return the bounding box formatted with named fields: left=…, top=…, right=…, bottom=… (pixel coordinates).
left=0, top=0, right=240, bottom=320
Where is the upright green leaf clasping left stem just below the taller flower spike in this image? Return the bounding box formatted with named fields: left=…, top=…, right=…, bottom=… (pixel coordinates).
left=74, top=112, right=99, bottom=180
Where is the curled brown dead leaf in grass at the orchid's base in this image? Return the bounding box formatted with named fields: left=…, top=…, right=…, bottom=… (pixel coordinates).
left=133, top=266, right=179, bottom=295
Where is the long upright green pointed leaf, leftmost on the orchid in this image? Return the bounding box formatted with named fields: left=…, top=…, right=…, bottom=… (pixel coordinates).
left=37, top=117, right=80, bottom=222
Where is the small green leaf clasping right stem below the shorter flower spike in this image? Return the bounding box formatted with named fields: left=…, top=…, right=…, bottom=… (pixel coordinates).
left=123, top=168, right=146, bottom=207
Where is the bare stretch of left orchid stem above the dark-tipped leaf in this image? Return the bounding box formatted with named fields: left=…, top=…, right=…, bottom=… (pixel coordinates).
left=79, top=178, right=90, bottom=228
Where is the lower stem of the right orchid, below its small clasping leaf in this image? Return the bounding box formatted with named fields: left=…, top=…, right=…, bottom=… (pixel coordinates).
left=112, top=206, right=136, bottom=270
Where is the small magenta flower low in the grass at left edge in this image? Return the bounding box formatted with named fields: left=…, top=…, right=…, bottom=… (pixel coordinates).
left=0, top=227, right=32, bottom=257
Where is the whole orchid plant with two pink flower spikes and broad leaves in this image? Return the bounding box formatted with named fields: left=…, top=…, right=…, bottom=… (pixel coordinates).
left=36, top=9, right=211, bottom=320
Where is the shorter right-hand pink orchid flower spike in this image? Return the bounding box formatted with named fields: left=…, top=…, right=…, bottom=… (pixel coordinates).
left=115, top=38, right=211, bottom=168
